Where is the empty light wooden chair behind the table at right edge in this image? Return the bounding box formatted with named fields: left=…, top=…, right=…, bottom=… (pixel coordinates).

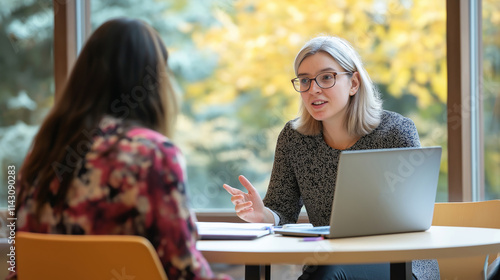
left=432, top=200, right=500, bottom=280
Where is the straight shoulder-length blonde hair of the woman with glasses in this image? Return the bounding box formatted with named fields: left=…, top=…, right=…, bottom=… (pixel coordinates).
left=293, top=36, right=382, bottom=136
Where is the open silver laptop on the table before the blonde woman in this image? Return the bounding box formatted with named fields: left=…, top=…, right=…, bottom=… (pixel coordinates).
left=274, top=147, right=441, bottom=238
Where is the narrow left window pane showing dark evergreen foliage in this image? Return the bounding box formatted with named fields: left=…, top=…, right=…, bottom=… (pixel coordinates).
left=0, top=1, right=54, bottom=207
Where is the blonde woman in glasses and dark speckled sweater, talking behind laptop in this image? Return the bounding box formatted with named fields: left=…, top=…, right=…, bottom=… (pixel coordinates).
left=224, top=36, right=439, bottom=279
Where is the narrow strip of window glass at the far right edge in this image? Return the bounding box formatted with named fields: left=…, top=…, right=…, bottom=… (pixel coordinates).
left=482, top=0, right=500, bottom=200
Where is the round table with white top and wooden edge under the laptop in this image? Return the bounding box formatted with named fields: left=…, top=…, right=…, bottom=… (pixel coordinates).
left=197, top=226, right=500, bottom=279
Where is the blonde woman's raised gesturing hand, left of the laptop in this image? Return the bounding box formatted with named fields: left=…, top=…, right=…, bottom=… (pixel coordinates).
left=223, top=175, right=274, bottom=224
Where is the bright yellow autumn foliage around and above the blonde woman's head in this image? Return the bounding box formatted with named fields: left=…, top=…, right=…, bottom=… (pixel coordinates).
left=187, top=0, right=446, bottom=110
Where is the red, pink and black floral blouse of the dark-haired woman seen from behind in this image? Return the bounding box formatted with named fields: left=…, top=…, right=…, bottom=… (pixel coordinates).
left=17, top=117, right=229, bottom=279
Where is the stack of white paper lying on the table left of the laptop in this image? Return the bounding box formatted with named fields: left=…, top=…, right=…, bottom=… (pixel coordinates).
left=196, top=222, right=273, bottom=240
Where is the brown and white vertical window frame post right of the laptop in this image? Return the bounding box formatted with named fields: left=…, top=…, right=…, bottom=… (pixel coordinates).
left=446, top=0, right=484, bottom=202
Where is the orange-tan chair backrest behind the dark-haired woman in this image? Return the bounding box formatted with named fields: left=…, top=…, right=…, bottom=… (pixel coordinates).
left=15, top=232, right=167, bottom=280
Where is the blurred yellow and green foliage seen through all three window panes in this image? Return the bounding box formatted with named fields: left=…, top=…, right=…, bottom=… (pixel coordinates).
left=0, top=0, right=500, bottom=211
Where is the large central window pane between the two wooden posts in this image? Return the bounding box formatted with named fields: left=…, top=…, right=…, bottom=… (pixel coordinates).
left=92, top=0, right=448, bottom=209
